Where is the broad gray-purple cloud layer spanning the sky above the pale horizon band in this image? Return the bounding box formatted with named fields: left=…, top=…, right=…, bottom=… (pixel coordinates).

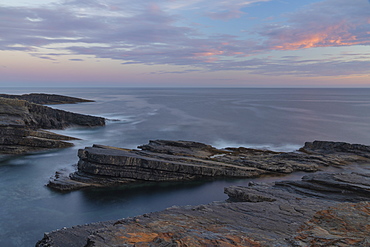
left=0, top=0, right=370, bottom=76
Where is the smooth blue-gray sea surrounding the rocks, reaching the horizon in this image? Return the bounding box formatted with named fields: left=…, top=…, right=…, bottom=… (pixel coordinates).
left=0, top=87, right=370, bottom=247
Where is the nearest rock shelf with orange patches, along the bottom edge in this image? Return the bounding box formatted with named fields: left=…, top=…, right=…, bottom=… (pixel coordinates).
left=36, top=173, right=370, bottom=247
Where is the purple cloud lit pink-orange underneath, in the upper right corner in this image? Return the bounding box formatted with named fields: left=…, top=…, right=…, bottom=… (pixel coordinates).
left=259, top=0, right=370, bottom=50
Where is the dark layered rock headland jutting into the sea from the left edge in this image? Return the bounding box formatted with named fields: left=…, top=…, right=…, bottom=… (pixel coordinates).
left=0, top=94, right=105, bottom=156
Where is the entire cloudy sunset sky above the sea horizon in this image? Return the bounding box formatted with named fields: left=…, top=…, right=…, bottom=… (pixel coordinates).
left=0, top=0, right=370, bottom=87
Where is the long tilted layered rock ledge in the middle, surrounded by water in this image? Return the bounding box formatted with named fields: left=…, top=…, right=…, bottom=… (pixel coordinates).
left=48, top=140, right=370, bottom=191
